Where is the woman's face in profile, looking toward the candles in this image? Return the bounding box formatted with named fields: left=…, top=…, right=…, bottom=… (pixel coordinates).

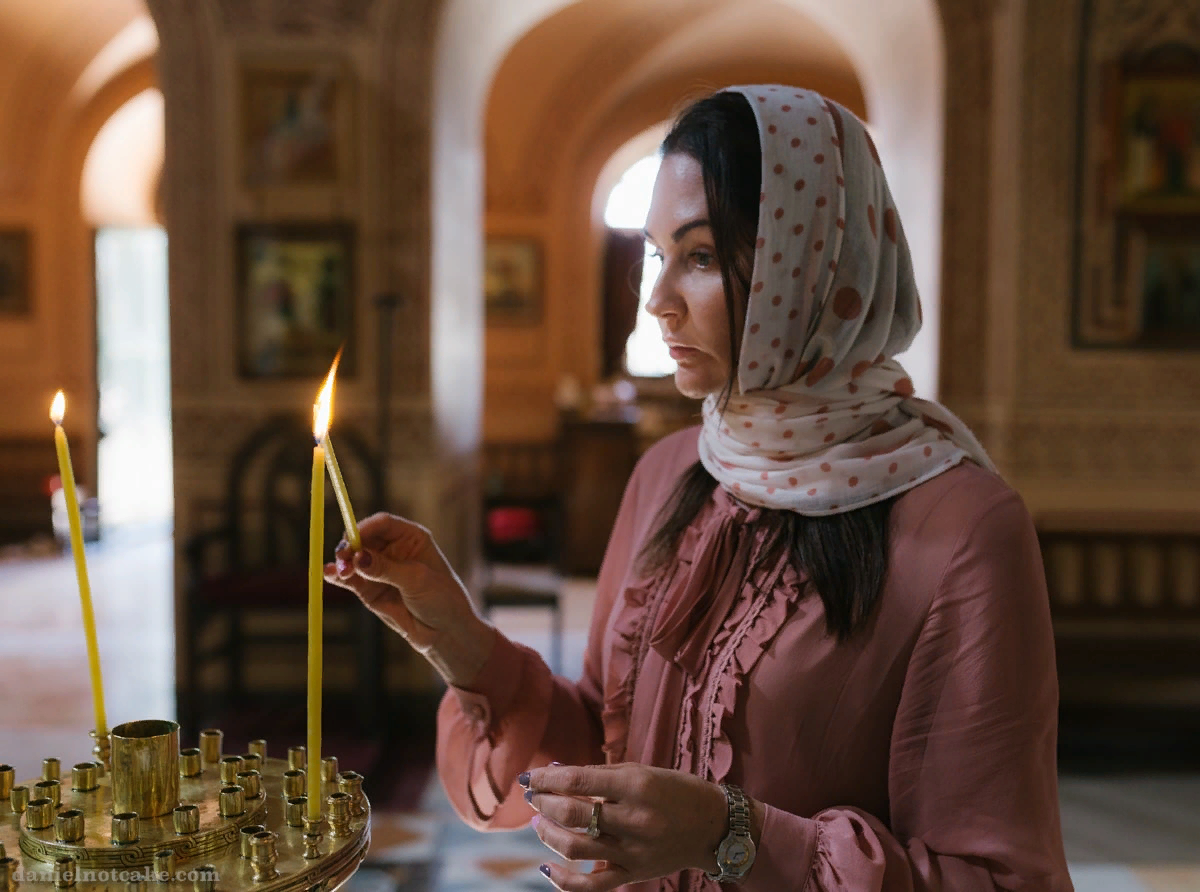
left=646, top=152, right=740, bottom=399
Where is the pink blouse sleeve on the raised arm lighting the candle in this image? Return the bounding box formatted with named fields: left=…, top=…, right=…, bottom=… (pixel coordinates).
left=437, top=465, right=642, bottom=830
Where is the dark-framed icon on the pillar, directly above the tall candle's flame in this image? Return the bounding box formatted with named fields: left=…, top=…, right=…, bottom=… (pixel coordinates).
left=238, top=223, right=354, bottom=378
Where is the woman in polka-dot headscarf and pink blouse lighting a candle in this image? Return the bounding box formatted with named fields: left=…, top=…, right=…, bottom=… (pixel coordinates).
left=329, top=86, right=1070, bottom=892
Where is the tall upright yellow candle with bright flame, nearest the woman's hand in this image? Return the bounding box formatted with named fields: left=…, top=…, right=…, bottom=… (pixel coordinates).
left=307, top=375, right=334, bottom=821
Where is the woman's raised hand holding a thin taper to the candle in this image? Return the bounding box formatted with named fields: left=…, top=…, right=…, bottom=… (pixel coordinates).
left=325, top=514, right=496, bottom=687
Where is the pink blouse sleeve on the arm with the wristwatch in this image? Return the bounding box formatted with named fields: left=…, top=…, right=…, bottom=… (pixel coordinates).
left=743, top=491, right=1072, bottom=892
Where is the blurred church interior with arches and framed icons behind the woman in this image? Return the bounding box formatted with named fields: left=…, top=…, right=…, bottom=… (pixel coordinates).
left=0, top=0, right=1200, bottom=892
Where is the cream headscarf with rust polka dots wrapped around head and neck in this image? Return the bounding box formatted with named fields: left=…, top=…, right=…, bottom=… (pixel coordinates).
left=700, top=85, right=994, bottom=515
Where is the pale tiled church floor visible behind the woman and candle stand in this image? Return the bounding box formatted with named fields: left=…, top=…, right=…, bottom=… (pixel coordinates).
left=0, top=534, right=1200, bottom=892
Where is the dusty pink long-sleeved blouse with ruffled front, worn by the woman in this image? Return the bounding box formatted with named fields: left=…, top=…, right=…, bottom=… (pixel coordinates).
left=437, top=429, right=1072, bottom=892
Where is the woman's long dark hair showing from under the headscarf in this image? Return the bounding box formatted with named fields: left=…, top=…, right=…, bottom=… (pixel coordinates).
left=638, top=92, right=892, bottom=641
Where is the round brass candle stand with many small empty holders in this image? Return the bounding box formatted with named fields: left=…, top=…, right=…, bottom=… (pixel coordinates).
left=0, top=719, right=371, bottom=892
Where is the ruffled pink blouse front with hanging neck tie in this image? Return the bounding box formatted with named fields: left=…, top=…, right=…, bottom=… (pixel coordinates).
left=602, top=489, right=806, bottom=783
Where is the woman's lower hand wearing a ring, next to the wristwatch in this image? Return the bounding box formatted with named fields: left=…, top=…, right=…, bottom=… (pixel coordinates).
left=518, top=762, right=728, bottom=892
